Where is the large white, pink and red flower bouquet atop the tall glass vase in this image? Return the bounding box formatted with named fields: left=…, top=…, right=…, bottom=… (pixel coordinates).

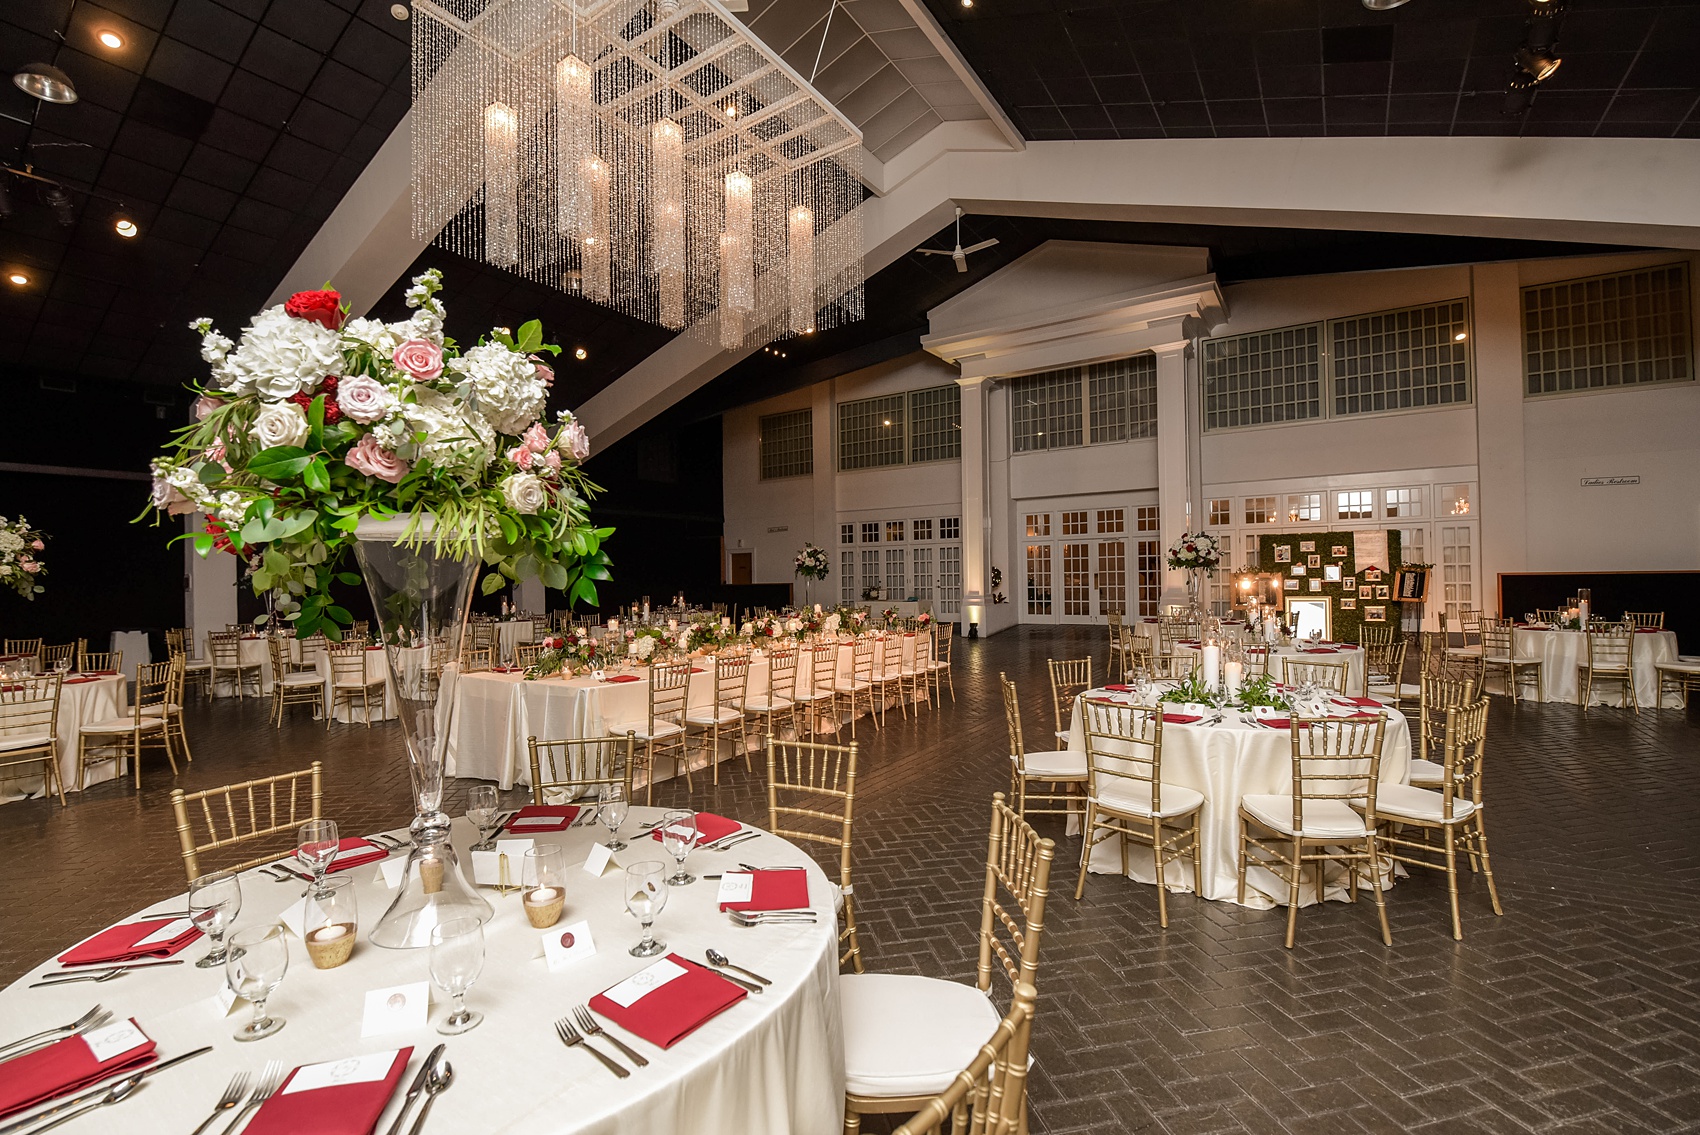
left=153, top=268, right=614, bottom=639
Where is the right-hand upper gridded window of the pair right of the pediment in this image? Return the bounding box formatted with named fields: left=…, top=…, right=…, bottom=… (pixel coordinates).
left=1328, top=299, right=1471, bottom=415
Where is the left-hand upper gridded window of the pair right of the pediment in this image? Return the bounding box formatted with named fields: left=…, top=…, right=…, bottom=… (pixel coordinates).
left=1204, top=323, right=1323, bottom=430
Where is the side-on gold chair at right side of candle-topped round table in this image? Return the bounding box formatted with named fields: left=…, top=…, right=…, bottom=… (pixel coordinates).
left=1375, top=698, right=1505, bottom=941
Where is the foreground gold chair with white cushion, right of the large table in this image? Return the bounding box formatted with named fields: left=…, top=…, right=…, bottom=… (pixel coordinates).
left=838, top=792, right=1056, bottom=1135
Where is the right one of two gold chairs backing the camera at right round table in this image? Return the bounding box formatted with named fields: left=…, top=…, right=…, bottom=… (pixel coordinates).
left=1239, top=714, right=1392, bottom=950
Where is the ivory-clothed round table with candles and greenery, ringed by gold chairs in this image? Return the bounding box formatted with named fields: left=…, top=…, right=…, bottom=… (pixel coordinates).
left=1068, top=690, right=1411, bottom=909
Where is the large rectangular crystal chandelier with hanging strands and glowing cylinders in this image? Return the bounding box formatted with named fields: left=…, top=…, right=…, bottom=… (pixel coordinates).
left=411, top=0, right=864, bottom=350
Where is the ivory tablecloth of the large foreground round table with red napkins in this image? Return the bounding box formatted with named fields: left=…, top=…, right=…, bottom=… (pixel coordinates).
left=0, top=807, right=845, bottom=1135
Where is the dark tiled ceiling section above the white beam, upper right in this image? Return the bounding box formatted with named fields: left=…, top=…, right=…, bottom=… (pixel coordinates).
left=927, top=0, right=1700, bottom=141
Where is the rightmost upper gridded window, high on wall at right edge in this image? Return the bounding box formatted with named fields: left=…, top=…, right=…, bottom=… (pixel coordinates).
left=1523, top=263, right=1693, bottom=394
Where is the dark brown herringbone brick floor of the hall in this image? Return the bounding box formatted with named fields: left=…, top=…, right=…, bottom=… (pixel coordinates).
left=0, top=629, right=1700, bottom=1135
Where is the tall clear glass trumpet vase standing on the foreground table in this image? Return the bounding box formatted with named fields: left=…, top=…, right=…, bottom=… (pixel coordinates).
left=355, top=518, right=495, bottom=950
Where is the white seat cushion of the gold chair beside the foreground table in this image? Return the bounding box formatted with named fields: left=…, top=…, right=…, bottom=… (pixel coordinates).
left=838, top=974, right=1001, bottom=1099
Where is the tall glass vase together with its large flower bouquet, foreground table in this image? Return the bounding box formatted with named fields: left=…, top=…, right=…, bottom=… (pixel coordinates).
left=153, top=270, right=612, bottom=946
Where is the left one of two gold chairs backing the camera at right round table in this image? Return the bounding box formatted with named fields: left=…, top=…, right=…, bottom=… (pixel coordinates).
left=1074, top=698, right=1204, bottom=928
